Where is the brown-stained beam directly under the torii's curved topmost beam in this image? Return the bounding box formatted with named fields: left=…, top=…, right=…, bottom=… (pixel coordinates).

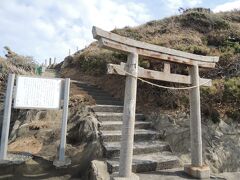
left=99, top=38, right=215, bottom=68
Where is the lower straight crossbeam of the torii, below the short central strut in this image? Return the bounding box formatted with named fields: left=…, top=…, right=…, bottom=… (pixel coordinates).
left=107, top=63, right=212, bottom=86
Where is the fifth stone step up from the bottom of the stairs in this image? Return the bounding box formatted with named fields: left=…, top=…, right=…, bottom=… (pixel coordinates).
left=95, top=112, right=145, bottom=122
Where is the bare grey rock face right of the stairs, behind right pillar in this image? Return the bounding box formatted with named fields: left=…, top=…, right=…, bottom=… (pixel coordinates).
left=148, top=113, right=240, bottom=173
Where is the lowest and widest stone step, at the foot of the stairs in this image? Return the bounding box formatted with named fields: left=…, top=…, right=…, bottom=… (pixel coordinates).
left=107, top=152, right=179, bottom=173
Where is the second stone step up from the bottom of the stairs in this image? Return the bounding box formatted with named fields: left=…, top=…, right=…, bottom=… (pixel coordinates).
left=103, top=141, right=171, bottom=158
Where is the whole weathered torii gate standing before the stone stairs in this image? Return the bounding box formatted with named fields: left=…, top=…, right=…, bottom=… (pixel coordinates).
left=92, top=26, right=219, bottom=180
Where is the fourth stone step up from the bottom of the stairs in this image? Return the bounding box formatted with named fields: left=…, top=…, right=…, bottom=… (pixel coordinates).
left=100, top=121, right=151, bottom=130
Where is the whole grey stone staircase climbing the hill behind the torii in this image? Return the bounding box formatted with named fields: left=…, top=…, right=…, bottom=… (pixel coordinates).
left=78, top=83, right=179, bottom=173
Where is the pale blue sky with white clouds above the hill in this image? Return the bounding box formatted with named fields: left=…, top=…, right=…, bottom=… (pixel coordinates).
left=0, top=0, right=240, bottom=63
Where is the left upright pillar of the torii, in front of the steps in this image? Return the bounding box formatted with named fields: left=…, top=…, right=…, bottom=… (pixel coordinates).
left=114, top=53, right=139, bottom=180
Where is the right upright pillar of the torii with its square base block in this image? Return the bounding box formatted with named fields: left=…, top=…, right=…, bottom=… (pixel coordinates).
left=184, top=65, right=210, bottom=179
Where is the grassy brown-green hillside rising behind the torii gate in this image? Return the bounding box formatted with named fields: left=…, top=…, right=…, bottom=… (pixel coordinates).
left=62, top=10, right=240, bottom=122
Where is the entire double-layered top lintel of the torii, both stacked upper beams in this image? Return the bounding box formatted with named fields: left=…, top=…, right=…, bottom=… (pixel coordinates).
left=92, top=26, right=219, bottom=68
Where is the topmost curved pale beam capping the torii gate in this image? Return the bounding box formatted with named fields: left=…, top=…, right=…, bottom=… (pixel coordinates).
left=92, top=26, right=219, bottom=63
